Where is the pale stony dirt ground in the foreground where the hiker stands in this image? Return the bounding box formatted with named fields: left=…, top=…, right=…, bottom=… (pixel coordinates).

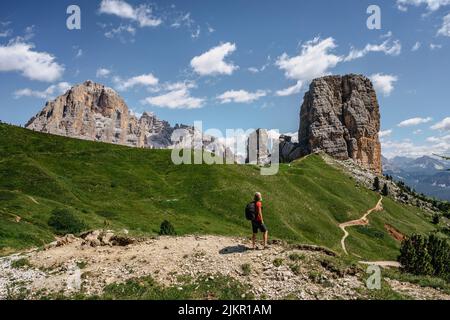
left=0, top=232, right=450, bottom=300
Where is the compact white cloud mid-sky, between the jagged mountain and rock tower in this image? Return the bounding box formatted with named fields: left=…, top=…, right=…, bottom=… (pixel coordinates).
left=191, top=42, right=238, bottom=76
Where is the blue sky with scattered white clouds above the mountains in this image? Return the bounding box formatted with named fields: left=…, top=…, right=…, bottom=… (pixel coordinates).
left=0, top=0, right=450, bottom=157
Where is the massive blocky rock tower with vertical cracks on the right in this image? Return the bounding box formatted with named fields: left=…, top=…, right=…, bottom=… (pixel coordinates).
left=298, top=75, right=381, bottom=173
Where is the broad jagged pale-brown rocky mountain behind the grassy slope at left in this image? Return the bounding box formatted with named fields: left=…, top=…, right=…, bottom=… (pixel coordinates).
left=26, top=81, right=179, bottom=148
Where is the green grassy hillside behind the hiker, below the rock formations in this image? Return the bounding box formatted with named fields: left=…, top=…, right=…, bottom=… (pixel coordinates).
left=0, top=125, right=440, bottom=259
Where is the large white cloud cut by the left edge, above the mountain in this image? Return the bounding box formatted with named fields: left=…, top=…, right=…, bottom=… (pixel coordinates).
left=0, top=41, right=64, bottom=82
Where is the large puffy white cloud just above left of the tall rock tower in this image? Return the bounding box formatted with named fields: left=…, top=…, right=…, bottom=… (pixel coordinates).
left=275, top=38, right=342, bottom=83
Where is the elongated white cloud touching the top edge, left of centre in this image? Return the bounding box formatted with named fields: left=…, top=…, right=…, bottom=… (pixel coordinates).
left=99, top=0, right=162, bottom=27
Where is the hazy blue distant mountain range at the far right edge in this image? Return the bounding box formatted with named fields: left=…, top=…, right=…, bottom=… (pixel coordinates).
left=382, top=156, right=450, bottom=201
